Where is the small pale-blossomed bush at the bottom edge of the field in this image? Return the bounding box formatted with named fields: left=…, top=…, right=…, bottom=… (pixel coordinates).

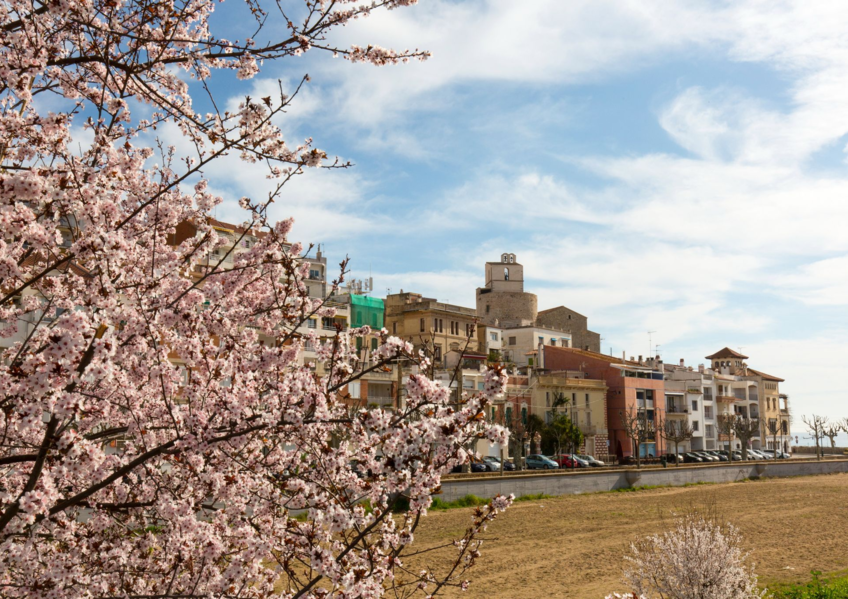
left=624, top=514, right=766, bottom=599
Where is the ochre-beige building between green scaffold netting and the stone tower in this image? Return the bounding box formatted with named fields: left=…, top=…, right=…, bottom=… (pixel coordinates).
left=385, top=291, right=478, bottom=367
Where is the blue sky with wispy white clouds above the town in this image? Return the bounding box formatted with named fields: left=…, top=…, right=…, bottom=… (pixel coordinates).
left=195, top=0, right=848, bottom=424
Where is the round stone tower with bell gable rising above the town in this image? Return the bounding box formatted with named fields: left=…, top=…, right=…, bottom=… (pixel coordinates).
left=477, top=253, right=537, bottom=327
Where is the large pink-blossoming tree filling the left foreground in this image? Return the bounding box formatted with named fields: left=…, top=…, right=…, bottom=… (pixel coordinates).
left=0, top=0, right=510, bottom=598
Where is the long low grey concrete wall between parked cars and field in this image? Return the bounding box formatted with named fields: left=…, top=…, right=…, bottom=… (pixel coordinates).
left=441, top=460, right=848, bottom=501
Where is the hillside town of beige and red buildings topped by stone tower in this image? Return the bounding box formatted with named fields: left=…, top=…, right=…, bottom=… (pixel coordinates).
left=154, top=221, right=791, bottom=462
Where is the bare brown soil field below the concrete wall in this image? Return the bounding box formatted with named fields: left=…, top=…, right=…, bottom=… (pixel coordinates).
left=415, top=474, right=848, bottom=599
